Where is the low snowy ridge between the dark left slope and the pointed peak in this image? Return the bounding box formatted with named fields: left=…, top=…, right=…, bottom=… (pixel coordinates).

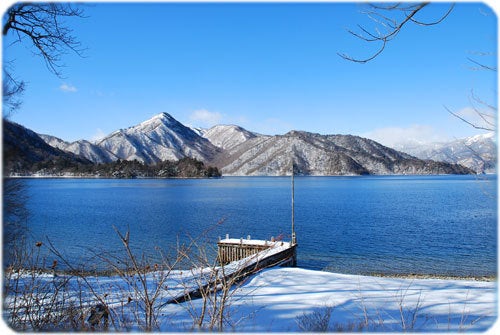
left=39, top=134, right=118, bottom=163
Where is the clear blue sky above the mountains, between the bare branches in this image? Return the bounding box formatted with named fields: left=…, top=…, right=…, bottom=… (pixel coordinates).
left=3, top=2, right=498, bottom=147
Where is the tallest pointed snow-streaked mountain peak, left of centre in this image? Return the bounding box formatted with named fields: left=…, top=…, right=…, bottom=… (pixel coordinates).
left=96, top=113, right=218, bottom=164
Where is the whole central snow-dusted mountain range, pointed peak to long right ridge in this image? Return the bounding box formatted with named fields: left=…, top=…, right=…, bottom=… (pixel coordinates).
left=31, top=113, right=472, bottom=175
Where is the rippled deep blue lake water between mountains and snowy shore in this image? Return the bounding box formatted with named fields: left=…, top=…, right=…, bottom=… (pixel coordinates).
left=9, top=176, right=497, bottom=276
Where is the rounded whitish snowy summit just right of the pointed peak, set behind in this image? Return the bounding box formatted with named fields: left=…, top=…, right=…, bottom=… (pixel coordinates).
left=202, top=125, right=259, bottom=150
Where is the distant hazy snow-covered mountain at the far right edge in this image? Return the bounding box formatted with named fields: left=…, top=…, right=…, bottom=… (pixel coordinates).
left=395, top=132, right=497, bottom=173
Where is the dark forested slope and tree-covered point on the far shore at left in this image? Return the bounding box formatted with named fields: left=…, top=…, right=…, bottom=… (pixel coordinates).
left=3, top=119, right=221, bottom=178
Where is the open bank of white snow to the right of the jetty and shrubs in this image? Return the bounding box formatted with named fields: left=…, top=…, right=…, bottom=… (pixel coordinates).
left=222, top=268, right=497, bottom=331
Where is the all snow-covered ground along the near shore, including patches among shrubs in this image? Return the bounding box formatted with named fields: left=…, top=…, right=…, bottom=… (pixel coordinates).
left=4, top=267, right=497, bottom=332
